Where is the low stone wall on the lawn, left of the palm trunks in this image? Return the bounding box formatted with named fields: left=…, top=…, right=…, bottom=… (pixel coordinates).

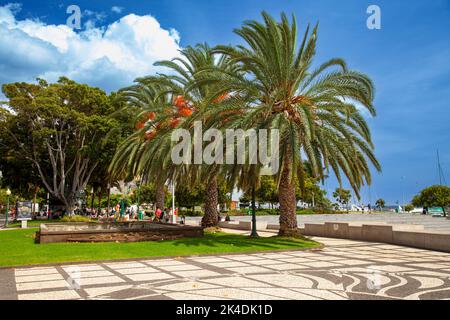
left=36, top=222, right=203, bottom=243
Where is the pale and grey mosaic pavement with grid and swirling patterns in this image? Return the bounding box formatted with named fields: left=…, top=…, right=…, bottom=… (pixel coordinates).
left=0, top=238, right=450, bottom=300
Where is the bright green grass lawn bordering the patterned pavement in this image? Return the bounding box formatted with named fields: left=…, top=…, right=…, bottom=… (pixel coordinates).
left=0, top=230, right=320, bottom=267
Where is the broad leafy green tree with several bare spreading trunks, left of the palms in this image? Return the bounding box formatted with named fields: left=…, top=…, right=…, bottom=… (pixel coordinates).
left=0, top=77, right=121, bottom=214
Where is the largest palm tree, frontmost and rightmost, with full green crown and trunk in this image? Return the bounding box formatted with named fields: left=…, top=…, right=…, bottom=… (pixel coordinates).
left=210, top=12, right=381, bottom=236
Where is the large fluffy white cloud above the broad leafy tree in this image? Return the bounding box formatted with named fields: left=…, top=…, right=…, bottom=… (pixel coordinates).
left=0, top=5, right=180, bottom=91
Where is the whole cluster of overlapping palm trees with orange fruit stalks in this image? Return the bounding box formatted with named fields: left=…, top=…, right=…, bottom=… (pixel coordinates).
left=110, top=12, right=380, bottom=236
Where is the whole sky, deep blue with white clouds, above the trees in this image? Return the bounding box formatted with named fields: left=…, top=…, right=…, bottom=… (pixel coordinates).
left=0, top=0, right=450, bottom=204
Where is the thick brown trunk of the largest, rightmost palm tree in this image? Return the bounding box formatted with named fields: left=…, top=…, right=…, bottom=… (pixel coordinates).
left=278, top=152, right=300, bottom=237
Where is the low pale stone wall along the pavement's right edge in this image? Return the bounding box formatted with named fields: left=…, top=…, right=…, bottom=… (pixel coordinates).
left=303, top=222, right=450, bottom=252
